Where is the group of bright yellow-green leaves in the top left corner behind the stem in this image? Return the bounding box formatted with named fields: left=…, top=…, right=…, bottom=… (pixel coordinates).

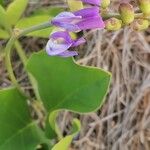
left=0, top=0, right=63, bottom=39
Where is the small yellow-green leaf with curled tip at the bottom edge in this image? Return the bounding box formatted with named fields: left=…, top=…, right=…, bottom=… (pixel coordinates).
left=52, top=119, right=81, bottom=150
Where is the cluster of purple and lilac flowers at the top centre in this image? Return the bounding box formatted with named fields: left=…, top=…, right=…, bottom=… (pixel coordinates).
left=46, top=0, right=105, bottom=57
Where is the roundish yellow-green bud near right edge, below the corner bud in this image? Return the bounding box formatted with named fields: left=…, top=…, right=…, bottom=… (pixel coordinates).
left=131, top=19, right=149, bottom=31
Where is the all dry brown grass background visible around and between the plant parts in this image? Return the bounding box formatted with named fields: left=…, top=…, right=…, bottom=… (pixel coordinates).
left=0, top=0, right=150, bottom=150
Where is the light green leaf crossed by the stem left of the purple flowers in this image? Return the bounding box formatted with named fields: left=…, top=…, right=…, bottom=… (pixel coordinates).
left=16, top=15, right=54, bottom=38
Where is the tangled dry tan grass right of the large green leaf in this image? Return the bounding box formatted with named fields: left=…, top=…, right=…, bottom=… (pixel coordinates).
left=57, top=0, right=150, bottom=150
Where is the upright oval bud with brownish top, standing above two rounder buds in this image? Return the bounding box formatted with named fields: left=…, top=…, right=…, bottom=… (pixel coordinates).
left=119, top=3, right=134, bottom=25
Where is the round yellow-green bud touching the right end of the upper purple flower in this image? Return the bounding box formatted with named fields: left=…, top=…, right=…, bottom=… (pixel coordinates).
left=105, top=18, right=122, bottom=31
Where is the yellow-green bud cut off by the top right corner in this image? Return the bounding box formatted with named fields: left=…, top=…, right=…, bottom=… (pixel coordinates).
left=138, top=0, right=150, bottom=14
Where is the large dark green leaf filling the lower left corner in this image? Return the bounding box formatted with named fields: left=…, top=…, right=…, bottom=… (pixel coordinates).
left=0, top=88, right=48, bottom=150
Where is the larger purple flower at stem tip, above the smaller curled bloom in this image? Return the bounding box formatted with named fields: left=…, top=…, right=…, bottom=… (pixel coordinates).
left=51, top=7, right=104, bottom=32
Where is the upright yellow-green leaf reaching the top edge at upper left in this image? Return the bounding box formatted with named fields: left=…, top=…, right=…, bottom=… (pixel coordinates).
left=6, top=0, right=28, bottom=25
